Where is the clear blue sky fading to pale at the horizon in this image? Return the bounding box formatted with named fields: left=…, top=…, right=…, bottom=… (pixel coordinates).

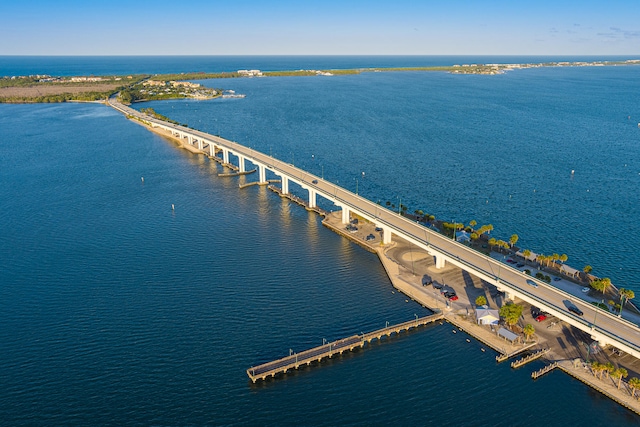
left=0, top=0, right=640, bottom=55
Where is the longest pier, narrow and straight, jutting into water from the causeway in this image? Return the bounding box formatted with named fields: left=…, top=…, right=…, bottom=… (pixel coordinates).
left=247, top=313, right=444, bottom=383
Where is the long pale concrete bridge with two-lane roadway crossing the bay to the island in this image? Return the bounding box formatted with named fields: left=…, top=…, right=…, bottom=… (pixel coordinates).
left=109, top=99, right=640, bottom=358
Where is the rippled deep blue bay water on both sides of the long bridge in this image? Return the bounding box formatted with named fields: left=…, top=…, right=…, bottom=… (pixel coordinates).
left=0, top=58, right=640, bottom=426
